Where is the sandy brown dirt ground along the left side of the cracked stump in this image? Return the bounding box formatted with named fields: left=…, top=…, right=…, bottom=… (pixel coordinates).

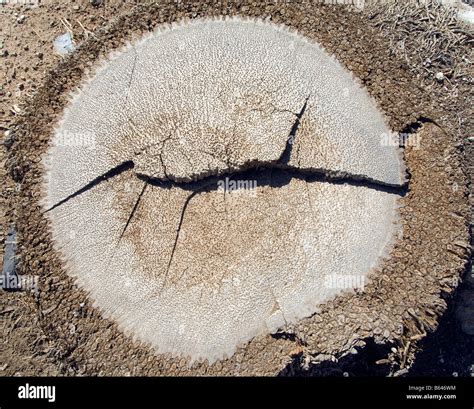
left=0, top=0, right=141, bottom=375
